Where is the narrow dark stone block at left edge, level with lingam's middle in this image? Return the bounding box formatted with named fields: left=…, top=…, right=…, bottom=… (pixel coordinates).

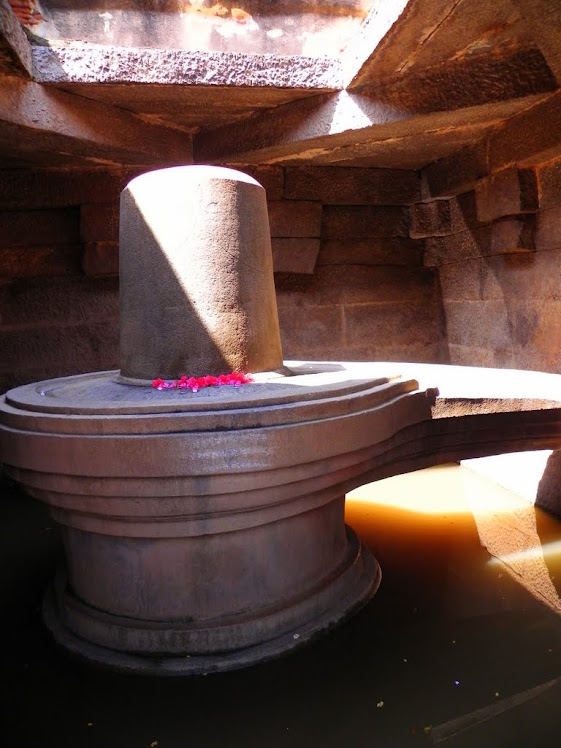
left=0, top=244, right=81, bottom=279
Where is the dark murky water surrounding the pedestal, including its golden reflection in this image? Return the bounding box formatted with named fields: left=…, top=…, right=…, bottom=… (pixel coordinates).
left=0, top=466, right=561, bottom=748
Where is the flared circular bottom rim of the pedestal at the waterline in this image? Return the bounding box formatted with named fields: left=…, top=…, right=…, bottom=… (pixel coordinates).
left=43, top=528, right=381, bottom=676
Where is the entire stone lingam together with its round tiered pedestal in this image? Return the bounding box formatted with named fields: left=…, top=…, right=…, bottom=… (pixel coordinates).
left=0, top=166, right=431, bottom=675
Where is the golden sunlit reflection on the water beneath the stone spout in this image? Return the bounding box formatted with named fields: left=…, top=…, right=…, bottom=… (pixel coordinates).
left=346, top=461, right=561, bottom=614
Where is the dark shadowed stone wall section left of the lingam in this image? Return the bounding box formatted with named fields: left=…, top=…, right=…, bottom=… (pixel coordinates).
left=0, top=169, right=135, bottom=390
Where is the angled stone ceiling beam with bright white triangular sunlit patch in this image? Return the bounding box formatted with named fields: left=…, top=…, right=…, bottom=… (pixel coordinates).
left=193, top=84, right=549, bottom=169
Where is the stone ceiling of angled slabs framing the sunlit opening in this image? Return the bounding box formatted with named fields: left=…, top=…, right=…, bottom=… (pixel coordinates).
left=0, top=0, right=561, bottom=169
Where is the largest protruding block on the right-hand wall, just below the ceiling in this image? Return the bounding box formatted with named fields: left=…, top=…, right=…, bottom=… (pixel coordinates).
left=475, top=167, right=538, bottom=223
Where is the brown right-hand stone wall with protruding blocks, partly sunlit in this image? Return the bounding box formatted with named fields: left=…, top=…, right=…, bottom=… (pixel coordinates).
left=411, top=145, right=561, bottom=372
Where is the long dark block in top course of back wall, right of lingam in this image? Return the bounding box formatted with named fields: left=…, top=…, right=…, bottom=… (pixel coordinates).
left=284, top=166, right=420, bottom=205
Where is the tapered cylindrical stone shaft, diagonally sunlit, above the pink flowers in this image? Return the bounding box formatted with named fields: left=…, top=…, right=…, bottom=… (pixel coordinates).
left=120, top=166, right=282, bottom=381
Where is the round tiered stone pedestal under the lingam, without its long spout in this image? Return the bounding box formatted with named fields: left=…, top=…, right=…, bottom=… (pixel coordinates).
left=0, top=364, right=430, bottom=674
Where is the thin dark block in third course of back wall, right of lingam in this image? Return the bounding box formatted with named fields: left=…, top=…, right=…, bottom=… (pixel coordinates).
left=317, top=236, right=423, bottom=265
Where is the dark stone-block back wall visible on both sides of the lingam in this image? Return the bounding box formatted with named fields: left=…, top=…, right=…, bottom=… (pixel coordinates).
left=0, top=166, right=447, bottom=391
